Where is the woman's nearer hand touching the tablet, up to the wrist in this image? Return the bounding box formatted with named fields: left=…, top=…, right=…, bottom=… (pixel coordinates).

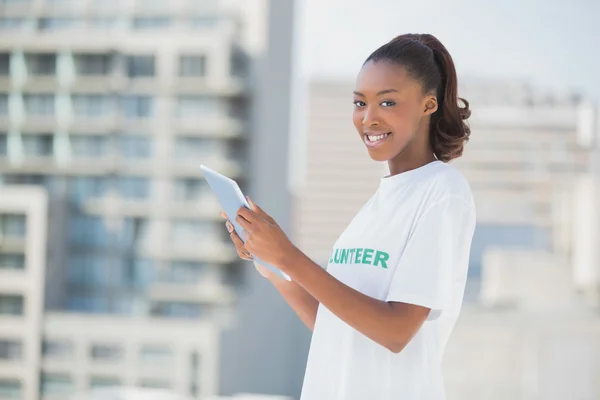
left=235, top=198, right=297, bottom=269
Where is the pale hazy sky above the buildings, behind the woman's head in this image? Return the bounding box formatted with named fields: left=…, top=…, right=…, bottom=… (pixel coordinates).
left=296, top=0, right=600, bottom=104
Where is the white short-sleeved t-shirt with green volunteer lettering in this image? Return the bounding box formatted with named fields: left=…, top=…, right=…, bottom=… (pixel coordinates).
left=301, top=161, right=475, bottom=400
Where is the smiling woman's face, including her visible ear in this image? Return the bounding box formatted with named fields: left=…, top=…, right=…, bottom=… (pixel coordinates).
left=352, top=61, right=437, bottom=161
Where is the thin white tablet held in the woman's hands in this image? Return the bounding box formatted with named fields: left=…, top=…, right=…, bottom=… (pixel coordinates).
left=200, top=165, right=291, bottom=281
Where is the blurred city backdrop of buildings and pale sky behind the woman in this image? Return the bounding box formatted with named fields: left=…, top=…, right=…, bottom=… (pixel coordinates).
left=0, top=0, right=600, bottom=400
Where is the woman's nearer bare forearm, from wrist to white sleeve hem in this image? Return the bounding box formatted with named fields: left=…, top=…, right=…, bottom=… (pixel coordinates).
left=278, top=250, right=430, bottom=353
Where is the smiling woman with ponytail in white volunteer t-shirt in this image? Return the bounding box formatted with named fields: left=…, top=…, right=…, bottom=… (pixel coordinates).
left=224, top=34, right=475, bottom=400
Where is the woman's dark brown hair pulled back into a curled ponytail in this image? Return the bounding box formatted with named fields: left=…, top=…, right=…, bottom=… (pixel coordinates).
left=365, top=34, right=471, bottom=162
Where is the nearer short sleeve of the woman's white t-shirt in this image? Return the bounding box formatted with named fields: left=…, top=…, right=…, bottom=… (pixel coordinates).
left=386, top=197, right=475, bottom=311
